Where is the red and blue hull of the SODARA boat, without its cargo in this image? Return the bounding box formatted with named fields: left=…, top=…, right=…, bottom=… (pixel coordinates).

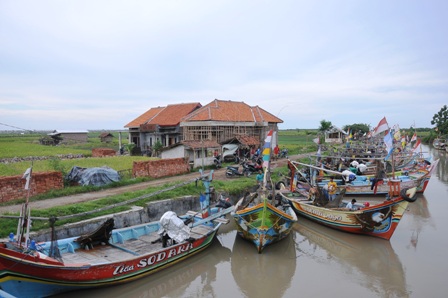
left=0, top=209, right=233, bottom=297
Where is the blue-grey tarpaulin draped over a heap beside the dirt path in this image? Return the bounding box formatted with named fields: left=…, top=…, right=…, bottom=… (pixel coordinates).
left=66, top=166, right=120, bottom=186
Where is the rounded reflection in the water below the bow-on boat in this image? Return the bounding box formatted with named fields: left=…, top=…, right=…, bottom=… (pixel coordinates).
left=231, top=233, right=296, bottom=297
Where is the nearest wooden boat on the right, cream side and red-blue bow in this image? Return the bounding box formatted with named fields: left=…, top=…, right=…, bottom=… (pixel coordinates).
left=277, top=161, right=417, bottom=240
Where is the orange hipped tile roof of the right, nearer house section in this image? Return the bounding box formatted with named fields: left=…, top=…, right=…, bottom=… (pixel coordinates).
left=182, top=99, right=283, bottom=123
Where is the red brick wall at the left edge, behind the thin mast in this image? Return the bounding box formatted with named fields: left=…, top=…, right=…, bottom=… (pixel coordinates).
left=0, top=172, right=64, bottom=202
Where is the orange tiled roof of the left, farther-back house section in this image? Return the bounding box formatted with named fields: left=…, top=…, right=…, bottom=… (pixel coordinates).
left=124, top=102, right=201, bottom=127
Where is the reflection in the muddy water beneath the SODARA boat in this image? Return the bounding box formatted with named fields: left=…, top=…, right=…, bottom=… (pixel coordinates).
left=60, top=239, right=231, bottom=298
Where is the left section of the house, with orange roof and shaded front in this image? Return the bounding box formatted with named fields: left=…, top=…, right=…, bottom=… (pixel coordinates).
left=124, top=102, right=202, bottom=152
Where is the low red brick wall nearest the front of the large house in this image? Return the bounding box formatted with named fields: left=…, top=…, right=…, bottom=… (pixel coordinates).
left=132, top=158, right=190, bottom=178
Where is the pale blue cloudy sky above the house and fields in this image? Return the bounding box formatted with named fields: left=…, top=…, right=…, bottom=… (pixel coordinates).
left=0, top=0, right=448, bottom=130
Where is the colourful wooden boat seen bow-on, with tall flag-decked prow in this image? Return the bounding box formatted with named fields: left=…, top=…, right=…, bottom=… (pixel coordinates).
left=231, top=130, right=297, bottom=253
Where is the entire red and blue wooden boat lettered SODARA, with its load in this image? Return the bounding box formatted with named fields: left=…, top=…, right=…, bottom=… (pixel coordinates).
left=0, top=169, right=233, bottom=297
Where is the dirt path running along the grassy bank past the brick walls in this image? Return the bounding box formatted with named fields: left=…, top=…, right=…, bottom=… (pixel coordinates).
left=0, top=156, right=298, bottom=214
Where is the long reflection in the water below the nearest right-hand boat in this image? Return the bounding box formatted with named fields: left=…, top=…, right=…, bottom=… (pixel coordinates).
left=294, top=219, right=410, bottom=297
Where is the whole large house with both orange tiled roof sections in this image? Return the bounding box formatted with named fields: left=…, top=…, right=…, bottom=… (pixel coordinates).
left=125, top=99, right=283, bottom=167
